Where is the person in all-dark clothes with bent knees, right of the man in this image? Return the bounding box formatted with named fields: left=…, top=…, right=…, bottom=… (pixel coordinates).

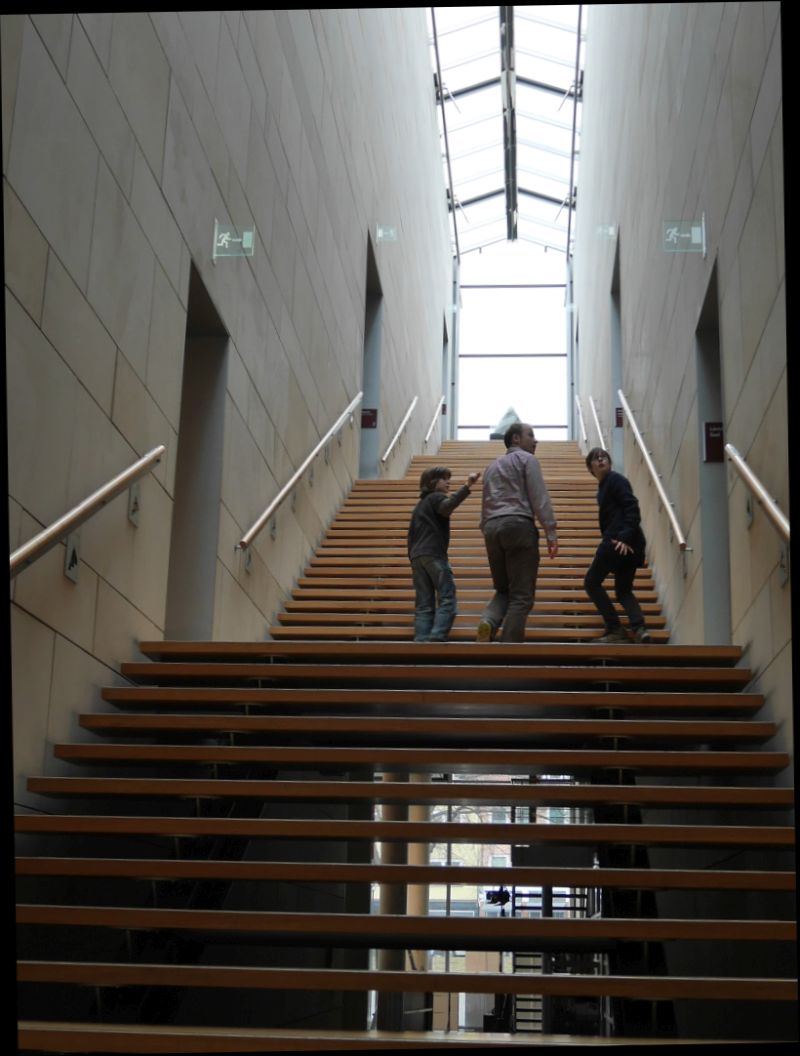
left=584, top=448, right=651, bottom=643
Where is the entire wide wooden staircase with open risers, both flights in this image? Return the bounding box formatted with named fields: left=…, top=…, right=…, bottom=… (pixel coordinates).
left=16, top=442, right=797, bottom=1053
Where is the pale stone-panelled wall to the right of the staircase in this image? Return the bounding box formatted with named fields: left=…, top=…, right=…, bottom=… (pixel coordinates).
left=575, top=3, right=792, bottom=760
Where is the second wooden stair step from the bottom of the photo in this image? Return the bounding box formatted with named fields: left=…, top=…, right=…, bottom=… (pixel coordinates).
left=17, top=961, right=797, bottom=1001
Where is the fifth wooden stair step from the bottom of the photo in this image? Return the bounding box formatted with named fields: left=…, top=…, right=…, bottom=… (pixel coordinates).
left=15, top=815, right=795, bottom=848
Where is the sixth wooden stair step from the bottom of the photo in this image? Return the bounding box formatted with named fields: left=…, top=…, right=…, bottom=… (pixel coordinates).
left=27, top=777, right=795, bottom=806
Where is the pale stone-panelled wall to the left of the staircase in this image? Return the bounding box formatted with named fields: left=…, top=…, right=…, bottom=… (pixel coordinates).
left=0, top=8, right=458, bottom=795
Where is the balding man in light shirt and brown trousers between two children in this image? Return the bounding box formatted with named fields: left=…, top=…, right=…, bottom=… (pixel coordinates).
left=478, top=421, right=558, bottom=642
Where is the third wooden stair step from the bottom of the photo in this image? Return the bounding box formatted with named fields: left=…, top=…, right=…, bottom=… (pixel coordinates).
left=16, top=903, right=797, bottom=950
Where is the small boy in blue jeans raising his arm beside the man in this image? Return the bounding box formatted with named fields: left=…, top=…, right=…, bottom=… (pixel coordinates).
left=408, top=466, right=480, bottom=642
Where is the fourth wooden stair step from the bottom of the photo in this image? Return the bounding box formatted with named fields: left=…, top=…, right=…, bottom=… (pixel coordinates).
left=15, top=856, right=796, bottom=891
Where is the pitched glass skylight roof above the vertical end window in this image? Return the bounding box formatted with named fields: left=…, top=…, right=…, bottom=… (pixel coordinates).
left=430, top=4, right=578, bottom=252
